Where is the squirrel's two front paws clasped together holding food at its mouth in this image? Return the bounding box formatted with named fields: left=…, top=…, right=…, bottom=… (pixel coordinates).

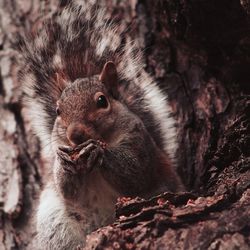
left=57, top=139, right=106, bottom=174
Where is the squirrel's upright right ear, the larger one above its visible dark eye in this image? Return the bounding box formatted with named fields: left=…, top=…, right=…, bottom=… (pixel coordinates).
left=99, top=61, right=118, bottom=90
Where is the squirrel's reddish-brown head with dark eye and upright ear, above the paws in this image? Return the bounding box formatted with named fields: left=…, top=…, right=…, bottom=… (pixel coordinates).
left=53, top=62, right=120, bottom=146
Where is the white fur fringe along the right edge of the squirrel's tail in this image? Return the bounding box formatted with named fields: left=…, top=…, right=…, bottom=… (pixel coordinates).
left=118, top=40, right=178, bottom=164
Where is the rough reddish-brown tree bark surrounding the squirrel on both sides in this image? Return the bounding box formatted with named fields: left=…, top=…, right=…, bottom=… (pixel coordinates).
left=0, top=0, right=250, bottom=250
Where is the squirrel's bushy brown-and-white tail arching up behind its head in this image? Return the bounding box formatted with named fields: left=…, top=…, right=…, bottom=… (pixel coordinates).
left=19, top=0, right=177, bottom=162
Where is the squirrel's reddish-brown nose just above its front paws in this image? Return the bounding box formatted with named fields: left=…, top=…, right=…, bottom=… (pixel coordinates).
left=66, top=122, right=86, bottom=146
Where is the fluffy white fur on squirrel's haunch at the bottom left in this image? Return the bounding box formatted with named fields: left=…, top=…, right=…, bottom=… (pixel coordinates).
left=36, top=187, right=83, bottom=250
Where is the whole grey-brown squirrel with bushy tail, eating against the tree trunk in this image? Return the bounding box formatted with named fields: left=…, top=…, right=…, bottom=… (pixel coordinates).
left=19, top=0, right=183, bottom=249
